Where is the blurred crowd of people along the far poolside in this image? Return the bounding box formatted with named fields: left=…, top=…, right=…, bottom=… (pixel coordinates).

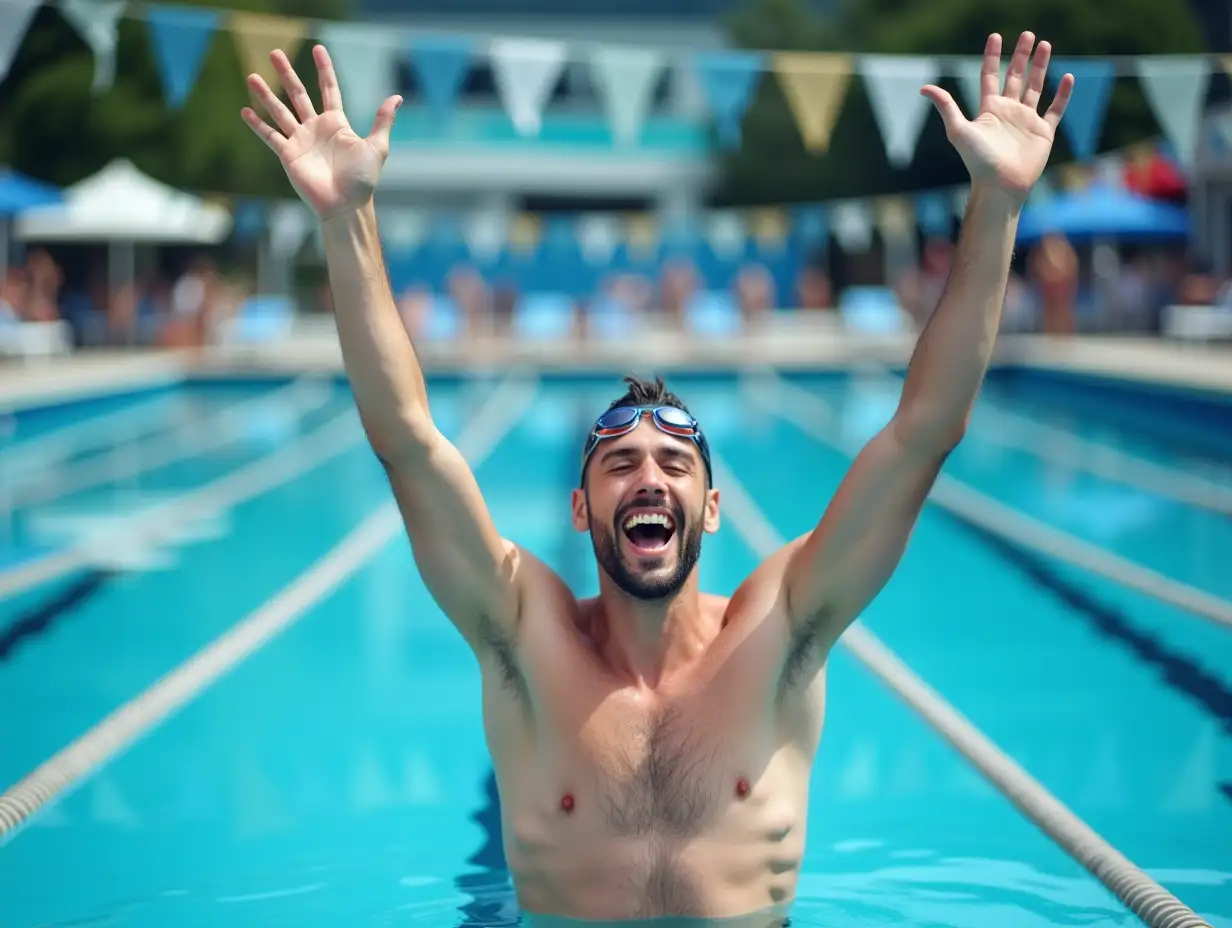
left=0, top=237, right=1232, bottom=348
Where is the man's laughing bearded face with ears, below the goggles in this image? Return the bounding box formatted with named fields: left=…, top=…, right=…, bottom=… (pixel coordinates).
left=573, top=419, right=718, bottom=599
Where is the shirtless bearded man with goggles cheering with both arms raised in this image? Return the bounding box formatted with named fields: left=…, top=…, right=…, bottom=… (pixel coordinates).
left=243, top=33, right=1073, bottom=919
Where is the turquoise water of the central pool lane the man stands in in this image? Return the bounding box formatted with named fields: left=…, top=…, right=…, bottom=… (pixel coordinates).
left=0, top=374, right=1132, bottom=928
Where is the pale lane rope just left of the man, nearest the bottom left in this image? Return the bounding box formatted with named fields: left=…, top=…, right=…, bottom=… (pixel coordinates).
left=0, top=373, right=538, bottom=845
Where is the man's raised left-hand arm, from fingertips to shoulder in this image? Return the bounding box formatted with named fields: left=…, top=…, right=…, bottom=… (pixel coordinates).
left=243, top=46, right=519, bottom=646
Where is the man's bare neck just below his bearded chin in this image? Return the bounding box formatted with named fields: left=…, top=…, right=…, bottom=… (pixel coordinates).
left=599, top=578, right=718, bottom=689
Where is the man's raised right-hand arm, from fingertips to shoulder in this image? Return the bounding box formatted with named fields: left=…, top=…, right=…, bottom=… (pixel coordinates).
left=782, top=32, right=1073, bottom=643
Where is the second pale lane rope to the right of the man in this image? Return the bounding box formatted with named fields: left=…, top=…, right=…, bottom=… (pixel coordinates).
left=750, top=376, right=1232, bottom=627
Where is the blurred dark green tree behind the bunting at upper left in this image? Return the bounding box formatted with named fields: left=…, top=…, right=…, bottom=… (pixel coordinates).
left=0, top=0, right=349, bottom=196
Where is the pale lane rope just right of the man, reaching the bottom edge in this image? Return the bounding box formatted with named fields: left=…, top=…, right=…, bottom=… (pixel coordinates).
left=711, top=449, right=1211, bottom=928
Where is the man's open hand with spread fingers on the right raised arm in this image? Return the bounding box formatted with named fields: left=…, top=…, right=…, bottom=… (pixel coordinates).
left=920, top=32, right=1074, bottom=200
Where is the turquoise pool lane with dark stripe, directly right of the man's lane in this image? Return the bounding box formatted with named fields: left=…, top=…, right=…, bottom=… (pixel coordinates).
left=721, top=377, right=1232, bottom=918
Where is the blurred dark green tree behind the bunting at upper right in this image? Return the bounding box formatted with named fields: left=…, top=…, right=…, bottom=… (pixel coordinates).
left=722, top=0, right=1204, bottom=203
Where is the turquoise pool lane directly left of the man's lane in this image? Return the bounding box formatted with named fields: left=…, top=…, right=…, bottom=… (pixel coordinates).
left=0, top=386, right=485, bottom=788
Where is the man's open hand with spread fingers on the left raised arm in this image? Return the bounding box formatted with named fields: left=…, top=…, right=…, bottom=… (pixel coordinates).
left=240, top=46, right=402, bottom=218
